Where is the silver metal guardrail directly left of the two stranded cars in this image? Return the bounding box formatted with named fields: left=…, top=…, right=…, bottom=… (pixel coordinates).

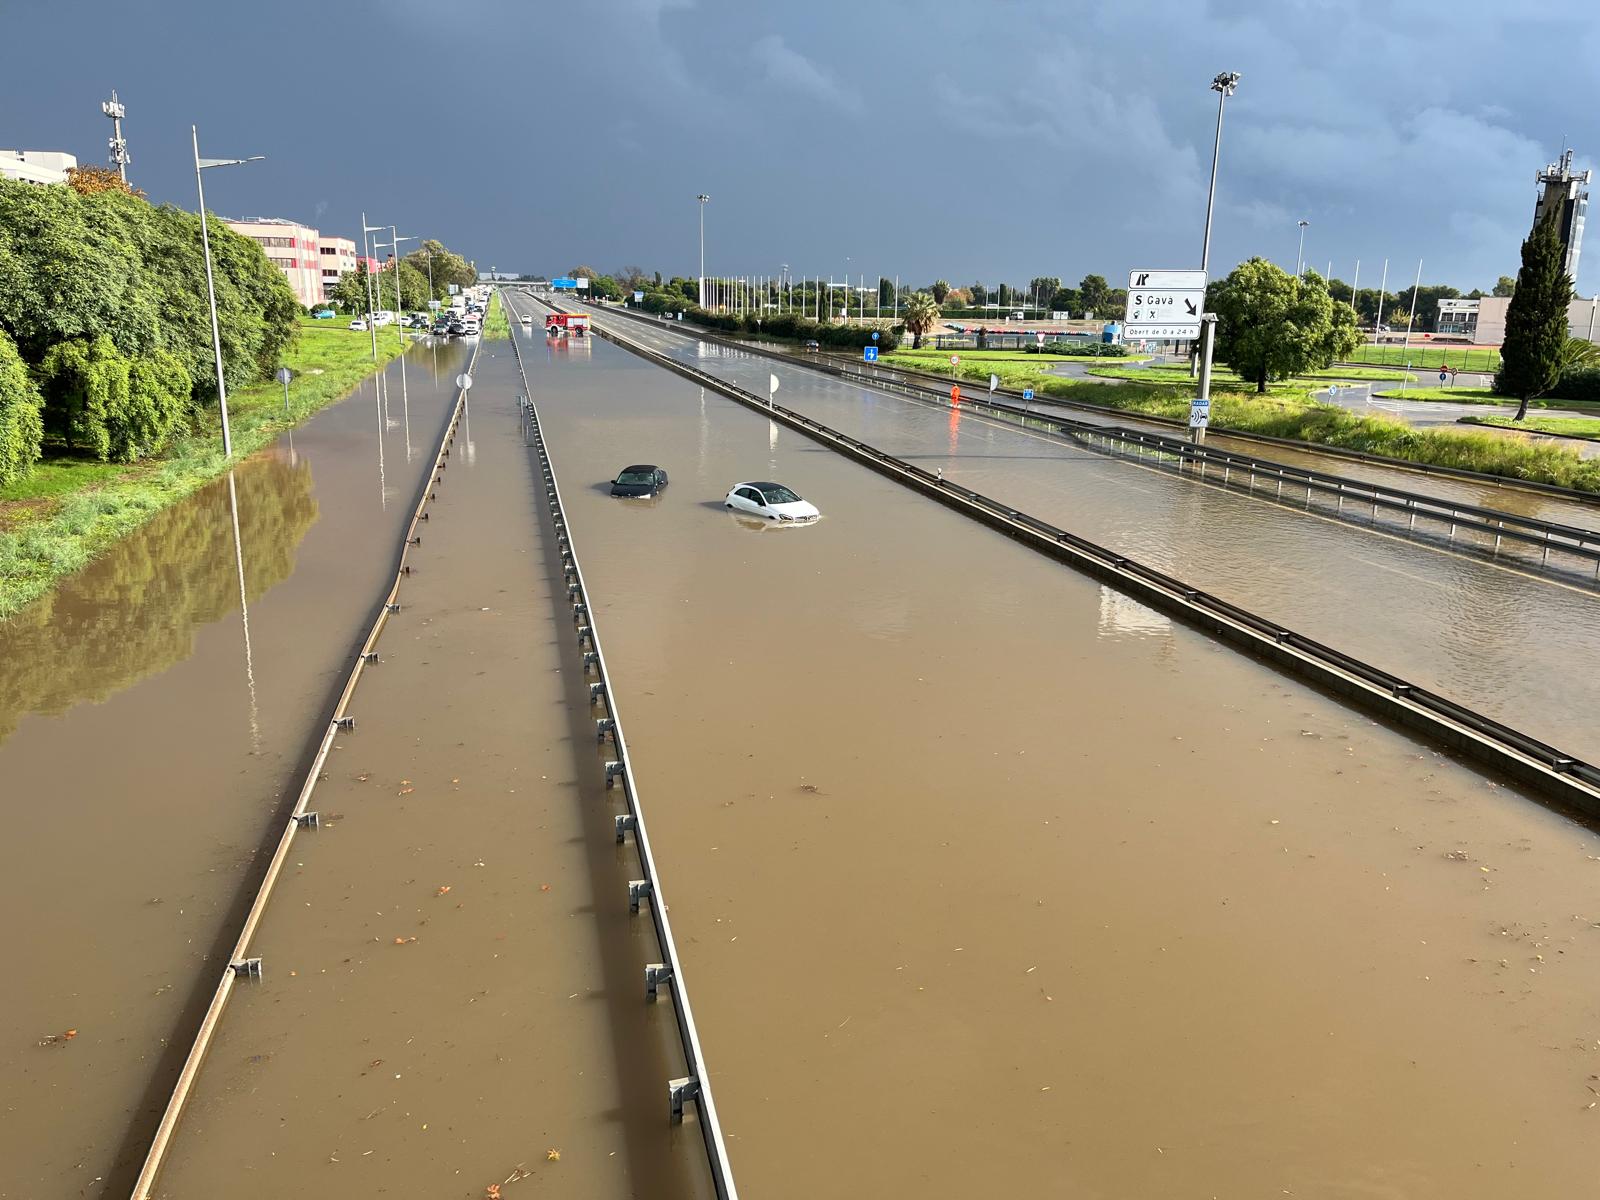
left=512, top=296, right=739, bottom=1200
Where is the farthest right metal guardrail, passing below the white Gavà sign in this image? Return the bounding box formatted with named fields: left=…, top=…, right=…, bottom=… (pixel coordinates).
left=598, top=314, right=1600, bottom=582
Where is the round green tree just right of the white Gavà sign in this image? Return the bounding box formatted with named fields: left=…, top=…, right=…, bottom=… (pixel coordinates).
left=1206, top=258, right=1360, bottom=392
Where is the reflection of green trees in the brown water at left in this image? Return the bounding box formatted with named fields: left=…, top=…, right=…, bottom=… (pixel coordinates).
left=0, top=454, right=317, bottom=741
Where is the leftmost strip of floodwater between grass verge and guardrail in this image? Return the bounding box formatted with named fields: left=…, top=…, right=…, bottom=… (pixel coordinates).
left=0, top=344, right=467, bottom=1200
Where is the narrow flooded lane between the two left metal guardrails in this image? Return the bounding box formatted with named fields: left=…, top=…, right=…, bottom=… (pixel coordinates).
left=157, top=342, right=707, bottom=1200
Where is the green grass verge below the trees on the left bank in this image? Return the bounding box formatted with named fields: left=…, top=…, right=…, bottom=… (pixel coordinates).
left=0, top=318, right=410, bottom=621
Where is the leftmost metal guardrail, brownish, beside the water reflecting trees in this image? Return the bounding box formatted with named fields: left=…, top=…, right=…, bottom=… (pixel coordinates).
left=133, top=347, right=478, bottom=1200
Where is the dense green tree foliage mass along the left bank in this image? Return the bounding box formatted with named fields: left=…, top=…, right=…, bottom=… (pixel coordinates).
left=0, top=179, right=299, bottom=478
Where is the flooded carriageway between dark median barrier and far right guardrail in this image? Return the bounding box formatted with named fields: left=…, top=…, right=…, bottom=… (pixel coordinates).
left=588, top=307, right=1600, bottom=762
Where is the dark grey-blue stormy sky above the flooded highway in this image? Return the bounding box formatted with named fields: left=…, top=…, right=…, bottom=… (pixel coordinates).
left=0, top=0, right=1600, bottom=294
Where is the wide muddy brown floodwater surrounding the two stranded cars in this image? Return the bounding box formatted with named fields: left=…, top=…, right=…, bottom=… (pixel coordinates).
left=505, top=305, right=1600, bottom=1200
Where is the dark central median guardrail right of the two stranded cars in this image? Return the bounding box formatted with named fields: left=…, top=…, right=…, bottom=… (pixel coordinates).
left=566, top=302, right=1600, bottom=819
